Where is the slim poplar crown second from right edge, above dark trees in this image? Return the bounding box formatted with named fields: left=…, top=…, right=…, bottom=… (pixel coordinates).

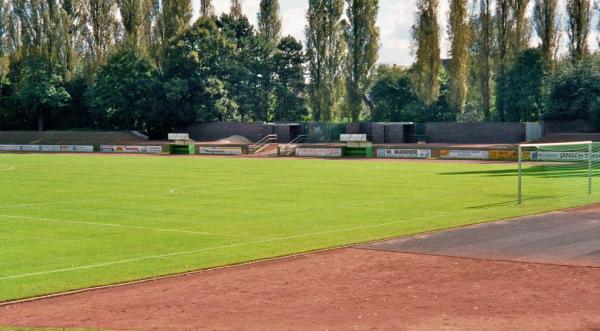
left=533, top=0, right=560, bottom=66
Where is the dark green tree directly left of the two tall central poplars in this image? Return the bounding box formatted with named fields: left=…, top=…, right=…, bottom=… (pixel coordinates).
left=273, top=36, right=308, bottom=121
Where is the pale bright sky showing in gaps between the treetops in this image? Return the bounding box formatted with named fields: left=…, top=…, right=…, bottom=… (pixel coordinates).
left=193, top=0, right=600, bottom=64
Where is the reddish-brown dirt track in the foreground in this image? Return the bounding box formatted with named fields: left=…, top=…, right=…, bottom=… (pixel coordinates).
left=0, top=248, right=600, bottom=330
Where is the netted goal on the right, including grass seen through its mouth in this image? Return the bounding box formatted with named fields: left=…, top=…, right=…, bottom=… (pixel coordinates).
left=518, top=141, right=600, bottom=207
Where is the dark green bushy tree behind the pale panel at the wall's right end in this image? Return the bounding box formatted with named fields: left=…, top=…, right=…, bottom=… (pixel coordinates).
left=498, top=49, right=545, bottom=122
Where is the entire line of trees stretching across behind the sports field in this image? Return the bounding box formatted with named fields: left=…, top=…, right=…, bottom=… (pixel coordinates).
left=0, top=0, right=600, bottom=136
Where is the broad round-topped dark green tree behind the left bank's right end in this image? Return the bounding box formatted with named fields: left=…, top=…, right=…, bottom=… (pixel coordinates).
left=87, top=48, right=162, bottom=132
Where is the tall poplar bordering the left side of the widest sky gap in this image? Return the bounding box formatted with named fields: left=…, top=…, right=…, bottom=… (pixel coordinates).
left=345, top=0, right=379, bottom=122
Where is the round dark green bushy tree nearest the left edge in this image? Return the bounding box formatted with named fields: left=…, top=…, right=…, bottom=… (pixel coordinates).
left=10, top=55, right=71, bottom=131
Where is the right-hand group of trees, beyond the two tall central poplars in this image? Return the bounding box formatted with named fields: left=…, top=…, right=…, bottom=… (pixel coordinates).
left=392, top=0, right=600, bottom=125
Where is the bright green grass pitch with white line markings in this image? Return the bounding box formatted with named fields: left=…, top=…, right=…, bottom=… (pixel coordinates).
left=0, top=154, right=596, bottom=301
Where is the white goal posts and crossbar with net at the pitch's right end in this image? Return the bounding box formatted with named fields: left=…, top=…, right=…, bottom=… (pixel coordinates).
left=518, top=141, right=600, bottom=204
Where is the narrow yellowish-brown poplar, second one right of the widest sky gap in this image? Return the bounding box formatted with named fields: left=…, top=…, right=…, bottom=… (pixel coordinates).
left=448, top=0, right=470, bottom=114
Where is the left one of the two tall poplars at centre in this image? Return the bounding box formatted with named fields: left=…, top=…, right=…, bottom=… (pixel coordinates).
left=306, top=0, right=345, bottom=121
